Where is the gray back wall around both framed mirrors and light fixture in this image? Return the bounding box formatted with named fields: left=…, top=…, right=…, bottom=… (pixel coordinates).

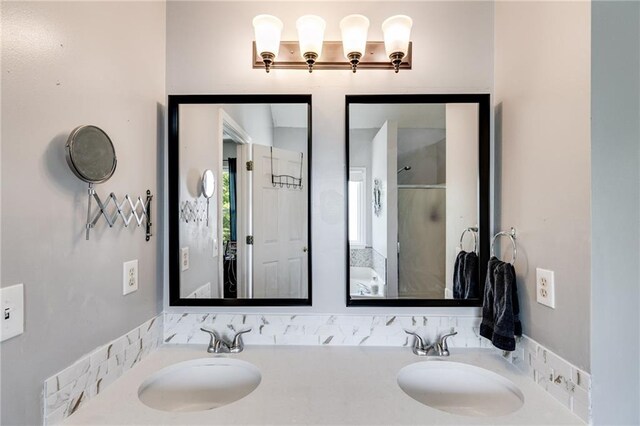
left=165, top=1, right=494, bottom=314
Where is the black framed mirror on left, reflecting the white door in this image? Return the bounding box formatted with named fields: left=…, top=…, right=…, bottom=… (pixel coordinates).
left=168, top=95, right=312, bottom=306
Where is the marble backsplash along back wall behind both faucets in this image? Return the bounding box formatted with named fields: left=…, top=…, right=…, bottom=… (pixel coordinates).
left=164, top=313, right=491, bottom=348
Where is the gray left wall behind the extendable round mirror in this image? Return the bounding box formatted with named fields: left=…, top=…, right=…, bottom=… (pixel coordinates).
left=0, top=2, right=165, bottom=425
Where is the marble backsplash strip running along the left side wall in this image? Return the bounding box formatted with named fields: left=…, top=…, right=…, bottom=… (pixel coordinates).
left=43, top=314, right=164, bottom=425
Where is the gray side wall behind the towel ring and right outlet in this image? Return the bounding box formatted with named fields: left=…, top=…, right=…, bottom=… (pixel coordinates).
left=495, top=2, right=591, bottom=371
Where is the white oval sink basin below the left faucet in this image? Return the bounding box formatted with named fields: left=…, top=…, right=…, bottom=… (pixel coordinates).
left=138, top=358, right=262, bottom=411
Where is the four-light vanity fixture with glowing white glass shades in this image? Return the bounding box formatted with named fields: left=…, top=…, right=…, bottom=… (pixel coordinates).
left=253, top=14, right=412, bottom=73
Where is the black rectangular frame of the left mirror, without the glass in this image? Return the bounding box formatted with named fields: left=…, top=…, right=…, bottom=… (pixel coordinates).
left=167, top=94, right=313, bottom=307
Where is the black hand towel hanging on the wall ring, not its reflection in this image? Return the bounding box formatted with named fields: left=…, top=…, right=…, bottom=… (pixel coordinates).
left=480, top=257, right=522, bottom=351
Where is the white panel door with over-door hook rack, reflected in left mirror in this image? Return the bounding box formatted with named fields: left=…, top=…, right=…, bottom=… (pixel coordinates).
left=252, top=145, right=309, bottom=298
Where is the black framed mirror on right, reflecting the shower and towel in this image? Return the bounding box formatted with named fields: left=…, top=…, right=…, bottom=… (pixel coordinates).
left=345, top=94, right=491, bottom=307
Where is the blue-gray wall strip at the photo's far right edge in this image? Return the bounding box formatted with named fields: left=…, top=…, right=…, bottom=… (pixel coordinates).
left=591, top=1, right=640, bottom=425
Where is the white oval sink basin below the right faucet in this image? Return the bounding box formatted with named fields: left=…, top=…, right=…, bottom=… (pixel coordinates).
left=398, top=361, right=524, bottom=417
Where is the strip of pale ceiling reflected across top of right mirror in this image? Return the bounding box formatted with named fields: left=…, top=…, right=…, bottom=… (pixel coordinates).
left=349, top=104, right=446, bottom=129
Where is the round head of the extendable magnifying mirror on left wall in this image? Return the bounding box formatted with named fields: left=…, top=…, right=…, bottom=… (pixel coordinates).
left=65, top=125, right=117, bottom=183
